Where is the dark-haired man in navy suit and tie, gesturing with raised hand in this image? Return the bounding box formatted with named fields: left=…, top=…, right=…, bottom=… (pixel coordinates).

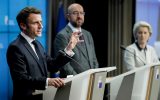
left=7, top=7, right=79, bottom=100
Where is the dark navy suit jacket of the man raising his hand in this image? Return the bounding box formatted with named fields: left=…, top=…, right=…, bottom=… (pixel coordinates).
left=7, top=35, right=70, bottom=100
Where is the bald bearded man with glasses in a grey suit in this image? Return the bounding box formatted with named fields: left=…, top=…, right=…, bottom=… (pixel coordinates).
left=54, top=3, right=99, bottom=77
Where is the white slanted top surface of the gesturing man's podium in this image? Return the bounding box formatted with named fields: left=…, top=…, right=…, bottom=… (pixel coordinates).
left=64, top=66, right=117, bottom=83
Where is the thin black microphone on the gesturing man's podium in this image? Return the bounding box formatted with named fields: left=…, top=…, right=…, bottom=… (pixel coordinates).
left=59, top=50, right=84, bottom=73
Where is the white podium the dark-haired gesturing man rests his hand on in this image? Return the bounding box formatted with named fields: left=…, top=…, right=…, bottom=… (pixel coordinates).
left=40, top=67, right=116, bottom=100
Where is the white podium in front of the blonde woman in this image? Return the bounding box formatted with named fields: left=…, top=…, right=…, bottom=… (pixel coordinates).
left=105, top=63, right=160, bottom=100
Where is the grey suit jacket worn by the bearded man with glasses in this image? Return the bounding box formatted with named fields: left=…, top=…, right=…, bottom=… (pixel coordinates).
left=54, top=25, right=99, bottom=77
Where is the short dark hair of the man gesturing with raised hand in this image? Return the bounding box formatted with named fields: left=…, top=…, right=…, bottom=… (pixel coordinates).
left=16, top=7, right=41, bottom=30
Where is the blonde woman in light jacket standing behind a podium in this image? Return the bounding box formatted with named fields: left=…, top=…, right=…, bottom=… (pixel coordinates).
left=124, top=21, right=159, bottom=72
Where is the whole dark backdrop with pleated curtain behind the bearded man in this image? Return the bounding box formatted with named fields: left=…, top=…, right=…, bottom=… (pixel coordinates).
left=48, top=0, right=136, bottom=76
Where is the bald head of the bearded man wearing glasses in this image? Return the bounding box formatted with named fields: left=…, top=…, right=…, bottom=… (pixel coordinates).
left=68, top=5, right=85, bottom=28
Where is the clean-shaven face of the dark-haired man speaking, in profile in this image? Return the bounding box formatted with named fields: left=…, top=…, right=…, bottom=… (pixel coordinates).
left=23, top=14, right=43, bottom=38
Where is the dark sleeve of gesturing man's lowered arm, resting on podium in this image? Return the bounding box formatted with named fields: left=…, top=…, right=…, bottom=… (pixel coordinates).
left=7, top=45, right=46, bottom=89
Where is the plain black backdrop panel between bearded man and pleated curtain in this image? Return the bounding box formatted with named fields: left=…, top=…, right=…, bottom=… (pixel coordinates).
left=73, top=0, right=108, bottom=67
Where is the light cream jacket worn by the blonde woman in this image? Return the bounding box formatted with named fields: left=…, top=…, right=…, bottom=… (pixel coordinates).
left=124, top=43, right=159, bottom=72
